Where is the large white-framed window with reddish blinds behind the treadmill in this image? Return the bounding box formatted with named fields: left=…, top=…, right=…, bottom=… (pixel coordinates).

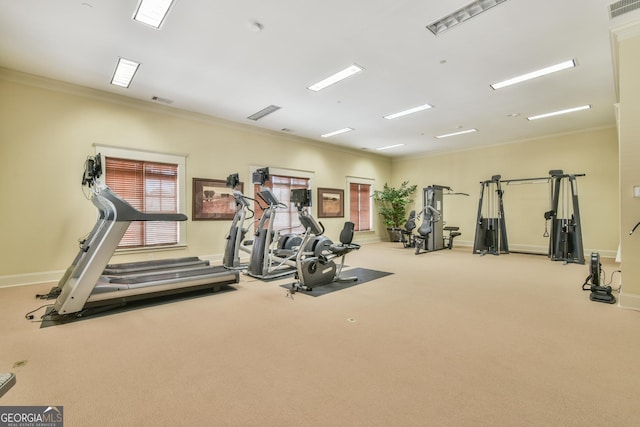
left=96, top=147, right=186, bottom=249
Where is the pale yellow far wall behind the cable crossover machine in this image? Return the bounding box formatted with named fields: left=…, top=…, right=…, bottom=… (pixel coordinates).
left=392, top=125, right=618, bottom=256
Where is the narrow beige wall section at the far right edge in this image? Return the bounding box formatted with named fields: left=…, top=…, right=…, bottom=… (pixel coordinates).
left=614, top=24, right=640, bottom=310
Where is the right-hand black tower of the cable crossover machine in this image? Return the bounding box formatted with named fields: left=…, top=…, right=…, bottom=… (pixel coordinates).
left=544, top=170, right=584, bottom=264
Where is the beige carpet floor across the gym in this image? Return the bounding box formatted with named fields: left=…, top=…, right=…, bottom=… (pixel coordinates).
left=0, top=243, right=640, bottom=427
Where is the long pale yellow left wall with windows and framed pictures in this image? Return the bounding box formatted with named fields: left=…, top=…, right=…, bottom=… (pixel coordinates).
left=0, top=70, right=391, bottom=286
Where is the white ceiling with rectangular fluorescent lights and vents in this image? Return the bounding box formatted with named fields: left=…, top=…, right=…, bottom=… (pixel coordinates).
left=0, top=0, right=640, bottom=157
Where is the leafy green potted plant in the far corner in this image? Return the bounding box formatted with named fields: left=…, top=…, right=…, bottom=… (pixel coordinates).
left=373, top=181, right=417, bottom=242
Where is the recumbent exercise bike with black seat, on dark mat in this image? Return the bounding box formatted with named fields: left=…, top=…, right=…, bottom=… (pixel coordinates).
left=291, top=189, right=360, bottom=293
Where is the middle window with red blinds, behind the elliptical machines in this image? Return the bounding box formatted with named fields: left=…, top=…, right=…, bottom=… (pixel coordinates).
left=254, top=174, right=309, bottom=233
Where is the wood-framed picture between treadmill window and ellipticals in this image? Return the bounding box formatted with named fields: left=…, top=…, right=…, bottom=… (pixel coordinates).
left=191, top=178, right=242, bottom=221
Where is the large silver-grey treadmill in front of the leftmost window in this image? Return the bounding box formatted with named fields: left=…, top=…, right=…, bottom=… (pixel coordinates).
left=46, top=154, right=240, bottom=320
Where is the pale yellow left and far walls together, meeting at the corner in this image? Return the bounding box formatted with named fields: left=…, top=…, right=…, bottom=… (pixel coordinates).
left=0, top=70, right=619, bottom=286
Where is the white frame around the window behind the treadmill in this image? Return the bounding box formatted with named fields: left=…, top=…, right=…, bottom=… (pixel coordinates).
left=94, top=145, right=188, bottom=252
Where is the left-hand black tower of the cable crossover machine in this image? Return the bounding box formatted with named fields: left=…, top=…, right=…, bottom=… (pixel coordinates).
left=473, top=175, right=509, bottom=255
